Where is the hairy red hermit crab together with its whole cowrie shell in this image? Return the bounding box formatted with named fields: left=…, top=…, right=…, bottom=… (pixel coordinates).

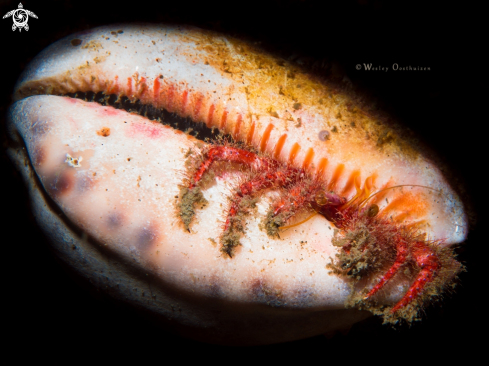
left=5, top=25, right=468, bottom=344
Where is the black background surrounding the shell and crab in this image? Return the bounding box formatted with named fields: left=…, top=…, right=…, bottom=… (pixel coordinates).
left=0, top=0, right=482, bottom=364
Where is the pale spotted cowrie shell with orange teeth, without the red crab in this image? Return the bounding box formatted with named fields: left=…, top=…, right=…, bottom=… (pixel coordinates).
left=5, top=25, right=468, bottom=344
